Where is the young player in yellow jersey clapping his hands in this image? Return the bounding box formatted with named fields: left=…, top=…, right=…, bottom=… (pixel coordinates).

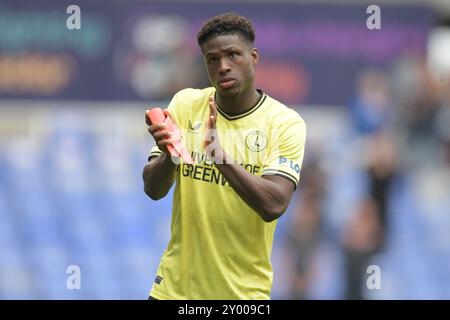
left=143, top=13, right=306, bottom=299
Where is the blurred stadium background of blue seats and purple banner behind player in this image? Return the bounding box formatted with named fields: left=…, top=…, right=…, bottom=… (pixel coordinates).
left=0, top=0, right=450, bottom=299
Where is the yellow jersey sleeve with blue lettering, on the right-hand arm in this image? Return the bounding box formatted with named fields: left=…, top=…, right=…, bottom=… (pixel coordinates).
left=261, top=111, right=306, bottom=188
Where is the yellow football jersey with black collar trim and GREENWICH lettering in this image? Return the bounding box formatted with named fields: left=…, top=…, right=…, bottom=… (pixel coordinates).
left=150, top=88, right=306, bottom=300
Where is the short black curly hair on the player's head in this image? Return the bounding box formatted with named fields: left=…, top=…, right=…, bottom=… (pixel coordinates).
left=197, top=12, right=255, bottom=47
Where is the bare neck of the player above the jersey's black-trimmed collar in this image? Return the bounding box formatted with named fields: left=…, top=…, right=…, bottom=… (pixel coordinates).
left=216, top=88, right=260, bottom=115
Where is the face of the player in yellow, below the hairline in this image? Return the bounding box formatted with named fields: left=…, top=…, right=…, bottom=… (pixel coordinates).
left=202, top=34, right=258, bottom=97
